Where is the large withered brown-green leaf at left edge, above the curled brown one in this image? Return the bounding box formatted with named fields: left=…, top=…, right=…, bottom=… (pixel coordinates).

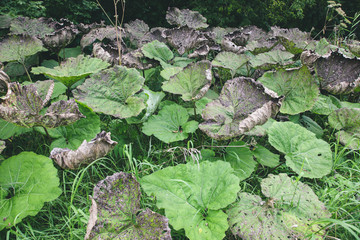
left=0, top=83, right=84, bottom=128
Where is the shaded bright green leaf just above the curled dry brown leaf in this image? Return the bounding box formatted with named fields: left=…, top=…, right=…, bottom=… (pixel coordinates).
left=36, top=102, right=100, bottom=150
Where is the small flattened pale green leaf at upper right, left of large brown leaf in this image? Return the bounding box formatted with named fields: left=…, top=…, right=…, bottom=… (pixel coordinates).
left=250, top=50, right=294, bottom=70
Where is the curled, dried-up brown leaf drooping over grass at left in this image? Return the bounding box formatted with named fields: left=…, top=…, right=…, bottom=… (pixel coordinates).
left=50, top=131, right=117, bottom=169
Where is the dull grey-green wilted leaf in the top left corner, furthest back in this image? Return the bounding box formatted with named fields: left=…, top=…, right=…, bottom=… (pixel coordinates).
left=10, top=17, right=55, bottom=39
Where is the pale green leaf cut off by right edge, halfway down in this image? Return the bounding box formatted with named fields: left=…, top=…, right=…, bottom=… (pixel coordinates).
left=329, top=108, right=360, bottom=150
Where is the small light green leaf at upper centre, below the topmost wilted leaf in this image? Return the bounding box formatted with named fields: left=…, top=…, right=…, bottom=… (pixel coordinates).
left=141, top=40, right=174, bottom=68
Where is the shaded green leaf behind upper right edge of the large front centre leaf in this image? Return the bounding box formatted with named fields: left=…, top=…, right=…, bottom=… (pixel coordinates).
left=225, top=141, right=257, bottom=181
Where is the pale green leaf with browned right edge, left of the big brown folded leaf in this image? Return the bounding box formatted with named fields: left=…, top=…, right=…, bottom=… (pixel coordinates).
left=162, top=61, right=212, bottom=101
